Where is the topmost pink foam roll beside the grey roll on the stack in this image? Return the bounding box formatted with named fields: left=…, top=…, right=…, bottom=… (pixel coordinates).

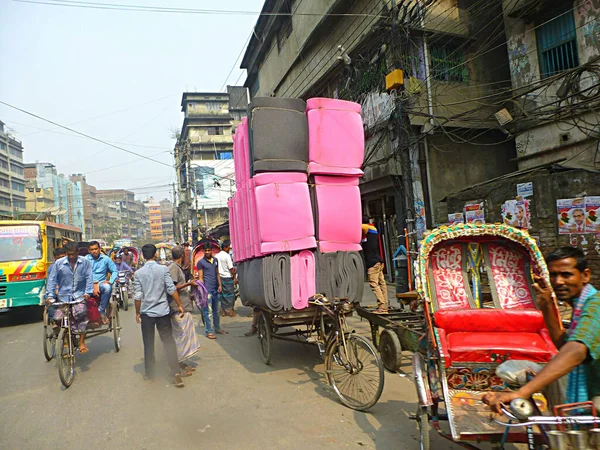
left=307, top=98, right=365, bottom=176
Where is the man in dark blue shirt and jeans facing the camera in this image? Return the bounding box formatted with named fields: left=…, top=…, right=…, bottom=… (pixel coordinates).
left=196, top=243, right=227, bottom=339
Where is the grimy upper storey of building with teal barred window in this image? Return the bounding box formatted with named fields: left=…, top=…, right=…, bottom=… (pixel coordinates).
left=503, top=0, right=600, bottom=171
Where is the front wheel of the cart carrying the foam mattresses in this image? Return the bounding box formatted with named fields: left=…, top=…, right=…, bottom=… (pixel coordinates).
left=325, top=334, right=384, bottom=411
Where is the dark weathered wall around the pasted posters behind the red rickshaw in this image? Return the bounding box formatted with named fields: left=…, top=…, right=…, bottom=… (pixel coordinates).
left=447, top=169, right=600, bottom=284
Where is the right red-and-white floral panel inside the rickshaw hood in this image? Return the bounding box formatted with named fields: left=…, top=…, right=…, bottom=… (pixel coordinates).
left=488, top=244, right=535, bottom=309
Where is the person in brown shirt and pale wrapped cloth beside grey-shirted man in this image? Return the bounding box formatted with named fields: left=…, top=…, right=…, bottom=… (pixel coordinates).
left=169, top=245, right=199, bottom=376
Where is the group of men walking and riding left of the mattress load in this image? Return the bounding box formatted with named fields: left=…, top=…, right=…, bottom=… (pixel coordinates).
left=46, top=241, right=237, bottom=387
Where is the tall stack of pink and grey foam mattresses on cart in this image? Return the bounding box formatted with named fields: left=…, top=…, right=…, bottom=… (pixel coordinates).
left=228, top=98, right=364, bottom=312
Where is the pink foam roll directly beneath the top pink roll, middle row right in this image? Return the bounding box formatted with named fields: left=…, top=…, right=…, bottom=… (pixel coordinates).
left=313, top=176, right=362, bottom=246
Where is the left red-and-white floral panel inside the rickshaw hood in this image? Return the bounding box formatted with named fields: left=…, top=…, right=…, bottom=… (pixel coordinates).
left=431, top=244, right=469, bottom=308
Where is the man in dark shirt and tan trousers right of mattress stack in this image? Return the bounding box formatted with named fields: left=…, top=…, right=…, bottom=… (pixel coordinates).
left=361, top=217, right=388, bottom=314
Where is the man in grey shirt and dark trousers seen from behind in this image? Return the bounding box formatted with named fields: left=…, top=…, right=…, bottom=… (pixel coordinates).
left=133, top=244, right=184, bottom=387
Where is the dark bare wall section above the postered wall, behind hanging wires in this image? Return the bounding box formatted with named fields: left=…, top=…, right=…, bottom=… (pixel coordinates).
left=428, top=131, right=516, bottom=224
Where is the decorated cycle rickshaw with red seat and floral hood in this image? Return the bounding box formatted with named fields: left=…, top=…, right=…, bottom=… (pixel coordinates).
left=412, top=224, right=559, bottom=449
